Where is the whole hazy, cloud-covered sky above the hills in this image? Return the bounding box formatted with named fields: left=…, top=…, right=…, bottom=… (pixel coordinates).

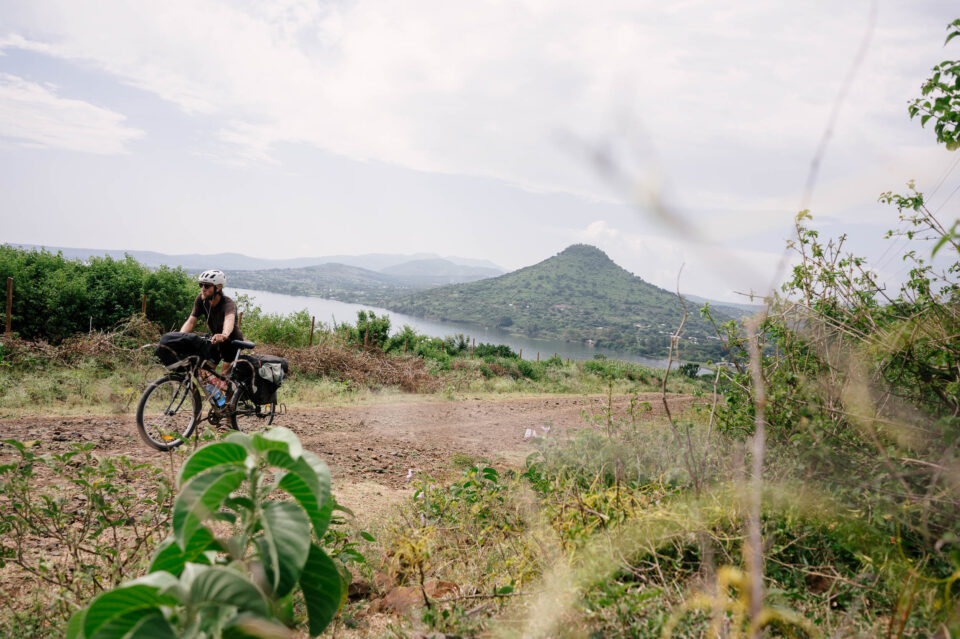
left=0, top=0, right=960, bottom=299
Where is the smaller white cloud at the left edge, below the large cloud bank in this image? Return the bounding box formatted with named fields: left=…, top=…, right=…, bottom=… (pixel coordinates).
left=0, top=73, right=143, bottom=154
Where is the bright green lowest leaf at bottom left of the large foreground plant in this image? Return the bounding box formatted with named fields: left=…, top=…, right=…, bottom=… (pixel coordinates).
left=83, top=584, right=180, bottom=639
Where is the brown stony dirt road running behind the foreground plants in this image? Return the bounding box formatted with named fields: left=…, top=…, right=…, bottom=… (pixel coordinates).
left=0, top=394, right=691, bottom=490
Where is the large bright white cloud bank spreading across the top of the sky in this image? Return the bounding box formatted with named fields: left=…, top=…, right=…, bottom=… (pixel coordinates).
left=0, top=0, right=945, bottom=199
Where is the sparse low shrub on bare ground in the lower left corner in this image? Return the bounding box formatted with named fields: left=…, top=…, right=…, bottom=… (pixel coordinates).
left=0, top=439, right=172, bottom=636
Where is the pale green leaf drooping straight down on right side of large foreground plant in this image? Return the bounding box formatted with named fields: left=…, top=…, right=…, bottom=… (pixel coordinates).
left=257, top=501, right=310, bottom=597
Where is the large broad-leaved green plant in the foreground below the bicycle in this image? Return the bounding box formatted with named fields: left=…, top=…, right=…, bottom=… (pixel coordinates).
left=66, top=428, right=345, bottom=639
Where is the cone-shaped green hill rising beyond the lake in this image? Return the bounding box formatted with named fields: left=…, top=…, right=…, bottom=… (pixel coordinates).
left=387, top=244, right=722, bottom=359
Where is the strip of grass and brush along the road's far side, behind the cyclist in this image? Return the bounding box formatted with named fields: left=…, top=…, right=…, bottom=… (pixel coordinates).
left=0, top=299, right=709, bottom=417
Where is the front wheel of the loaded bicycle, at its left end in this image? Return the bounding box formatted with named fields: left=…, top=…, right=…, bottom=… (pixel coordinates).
left=137, top=375, right=201, bottom=451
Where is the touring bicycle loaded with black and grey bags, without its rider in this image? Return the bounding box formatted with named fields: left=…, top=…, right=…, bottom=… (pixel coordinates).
left=137, top=332, right=289, bottom=450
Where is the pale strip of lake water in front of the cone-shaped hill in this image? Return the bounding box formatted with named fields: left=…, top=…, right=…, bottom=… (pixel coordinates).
left=226, top=286, right=667, bottom=368
